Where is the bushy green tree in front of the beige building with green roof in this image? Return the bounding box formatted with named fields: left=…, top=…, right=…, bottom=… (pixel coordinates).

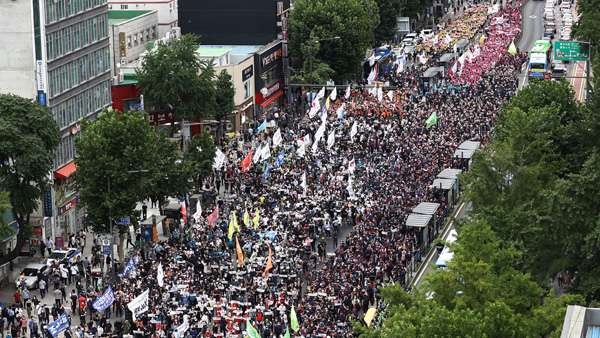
left=135, top=34, right=215, bottom=135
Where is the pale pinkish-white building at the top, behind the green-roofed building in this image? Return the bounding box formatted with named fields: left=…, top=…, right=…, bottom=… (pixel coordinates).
left=108, top=0, right=179, bottom=38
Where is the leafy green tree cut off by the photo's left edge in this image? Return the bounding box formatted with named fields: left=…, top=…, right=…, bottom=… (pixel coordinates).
left=0, top=94, right=60, bottom=263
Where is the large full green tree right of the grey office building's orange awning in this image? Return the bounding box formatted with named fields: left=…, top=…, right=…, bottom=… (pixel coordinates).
left=75, top=109, right=157, bottom=264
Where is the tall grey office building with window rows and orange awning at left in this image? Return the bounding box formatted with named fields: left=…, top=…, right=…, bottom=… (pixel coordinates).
left=0, top=0, right=111, bottom=244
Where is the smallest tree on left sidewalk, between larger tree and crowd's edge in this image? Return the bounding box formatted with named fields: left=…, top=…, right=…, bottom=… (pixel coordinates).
left=183, top=134, right=217, bottom=186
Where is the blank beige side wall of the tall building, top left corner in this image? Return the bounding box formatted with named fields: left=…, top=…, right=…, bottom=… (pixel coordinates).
left=0, top=0, right=37, bottom=99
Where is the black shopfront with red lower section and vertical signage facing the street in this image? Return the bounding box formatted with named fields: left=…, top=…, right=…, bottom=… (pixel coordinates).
left=253, top=40, right=284, bottom=123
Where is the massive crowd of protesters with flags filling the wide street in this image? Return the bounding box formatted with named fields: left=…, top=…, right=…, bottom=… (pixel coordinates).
left=7, top=0, right=521, bottom=338
